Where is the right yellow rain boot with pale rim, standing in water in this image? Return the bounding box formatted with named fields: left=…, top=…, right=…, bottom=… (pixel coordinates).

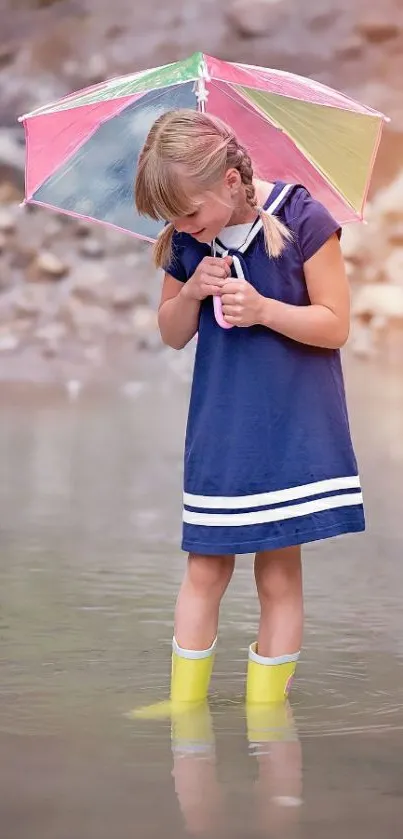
left=246, top=644, right=299, bottom=705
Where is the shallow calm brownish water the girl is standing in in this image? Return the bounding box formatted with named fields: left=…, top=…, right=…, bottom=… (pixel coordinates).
left=0, top=356, right=403, bottom=839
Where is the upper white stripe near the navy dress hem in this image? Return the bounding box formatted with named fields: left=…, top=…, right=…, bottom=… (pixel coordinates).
left=183, top=475, right=361, bottom=510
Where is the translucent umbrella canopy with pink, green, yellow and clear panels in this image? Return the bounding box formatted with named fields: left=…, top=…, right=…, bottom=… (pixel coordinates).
left=20, top=53, right=386, bottom=241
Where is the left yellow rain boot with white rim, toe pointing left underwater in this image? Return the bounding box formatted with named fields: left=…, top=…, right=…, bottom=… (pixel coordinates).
left=129, top=638, right=216, bottom=719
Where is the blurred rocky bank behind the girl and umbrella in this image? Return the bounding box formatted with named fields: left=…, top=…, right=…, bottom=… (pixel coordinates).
left=0, top=0, right=403, bottom=382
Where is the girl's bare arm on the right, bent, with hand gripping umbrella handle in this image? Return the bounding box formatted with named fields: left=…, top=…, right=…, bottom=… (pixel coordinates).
left=221, top=234, right=350, bottom=349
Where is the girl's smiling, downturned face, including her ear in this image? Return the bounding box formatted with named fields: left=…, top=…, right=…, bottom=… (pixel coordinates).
left=169, top=170, right=241, bottom=243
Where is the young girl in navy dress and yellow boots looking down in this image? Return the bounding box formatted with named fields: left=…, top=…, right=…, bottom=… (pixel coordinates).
left=135, top=109, right=365, bottom=715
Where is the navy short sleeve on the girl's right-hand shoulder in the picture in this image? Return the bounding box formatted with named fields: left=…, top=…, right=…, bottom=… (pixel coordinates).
left=290, top=188, right=341, bottom=262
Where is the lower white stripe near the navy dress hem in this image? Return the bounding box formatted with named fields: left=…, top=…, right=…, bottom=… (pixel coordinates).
left=183, top=492, right=363, bottom=527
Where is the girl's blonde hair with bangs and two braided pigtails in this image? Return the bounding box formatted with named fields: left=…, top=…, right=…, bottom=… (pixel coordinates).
left=135, top=108, right=292, bottom=267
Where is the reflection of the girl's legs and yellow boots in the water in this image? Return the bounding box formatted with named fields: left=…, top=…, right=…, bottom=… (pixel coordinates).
left=168, top=703, right=302, bottom=837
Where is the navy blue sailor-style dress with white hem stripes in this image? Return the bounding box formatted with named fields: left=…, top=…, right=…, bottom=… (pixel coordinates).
left=167, top=182, right=365, bottom=555
